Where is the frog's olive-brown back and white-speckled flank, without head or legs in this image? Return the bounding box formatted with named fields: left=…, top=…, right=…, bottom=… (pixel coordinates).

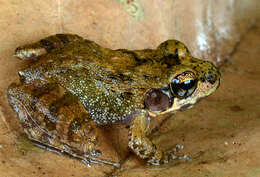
left=17, top=40, right=165, bottom=124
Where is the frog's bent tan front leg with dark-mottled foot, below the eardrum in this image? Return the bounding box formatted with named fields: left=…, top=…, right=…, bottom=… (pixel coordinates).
left=128, top=111, right=182, bottom=165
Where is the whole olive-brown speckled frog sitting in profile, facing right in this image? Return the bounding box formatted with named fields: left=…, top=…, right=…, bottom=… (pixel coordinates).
left=6, top=34, right=220, bottom=167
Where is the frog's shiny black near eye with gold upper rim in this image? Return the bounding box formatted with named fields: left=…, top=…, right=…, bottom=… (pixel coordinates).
left=170, top=71, right=197, bottom=99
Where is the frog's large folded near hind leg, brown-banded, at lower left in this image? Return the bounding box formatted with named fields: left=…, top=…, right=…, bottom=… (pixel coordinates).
left=7, top=84, right=120, bottom=167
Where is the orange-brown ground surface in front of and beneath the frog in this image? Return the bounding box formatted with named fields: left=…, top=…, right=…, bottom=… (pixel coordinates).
left=0, top=26, right=260, bottom=177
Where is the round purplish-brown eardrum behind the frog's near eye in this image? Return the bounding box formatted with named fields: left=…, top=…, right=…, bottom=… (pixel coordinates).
left=144, top=89, right=171, bottom=112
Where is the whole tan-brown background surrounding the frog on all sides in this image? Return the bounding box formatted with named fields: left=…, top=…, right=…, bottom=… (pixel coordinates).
left=0, top=0, right=260, bottom=177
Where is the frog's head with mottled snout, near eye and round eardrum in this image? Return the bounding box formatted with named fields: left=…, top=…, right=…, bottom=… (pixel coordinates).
left=144, top=41, right=220, bottom=116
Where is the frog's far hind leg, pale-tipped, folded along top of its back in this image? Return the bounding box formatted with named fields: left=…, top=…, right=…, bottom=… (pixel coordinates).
left=14, top=34, right=83, bottom=60
